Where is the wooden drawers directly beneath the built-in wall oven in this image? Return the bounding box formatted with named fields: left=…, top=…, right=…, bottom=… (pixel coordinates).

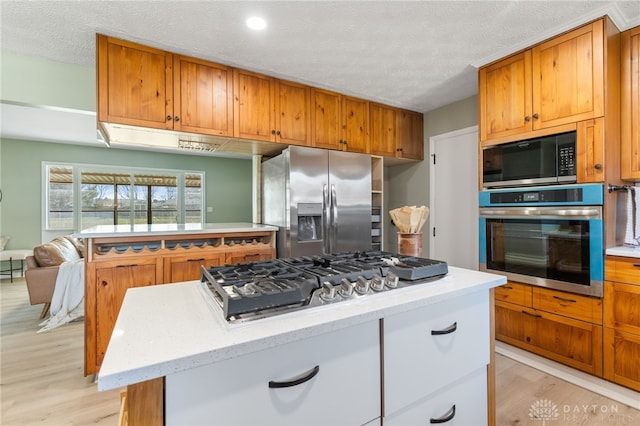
left=495, top=282, right=603, bottom=377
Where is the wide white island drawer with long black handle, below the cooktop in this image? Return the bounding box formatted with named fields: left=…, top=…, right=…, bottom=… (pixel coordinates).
left=165, top=320, right=381, bottom=426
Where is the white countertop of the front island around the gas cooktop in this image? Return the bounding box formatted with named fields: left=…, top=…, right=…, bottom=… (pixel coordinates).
left=98, top=266, right=506, bottom=391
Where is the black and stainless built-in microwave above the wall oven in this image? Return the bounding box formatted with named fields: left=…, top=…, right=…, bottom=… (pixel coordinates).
left=482, top=132, right=576, bottom=188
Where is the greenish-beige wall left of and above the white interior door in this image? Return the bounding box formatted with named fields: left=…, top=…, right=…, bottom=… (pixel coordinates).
left=384, top=96, right=478, bottom=253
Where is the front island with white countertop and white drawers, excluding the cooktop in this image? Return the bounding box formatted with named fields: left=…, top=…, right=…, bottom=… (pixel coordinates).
left=98, top=267, right=506, bottom=425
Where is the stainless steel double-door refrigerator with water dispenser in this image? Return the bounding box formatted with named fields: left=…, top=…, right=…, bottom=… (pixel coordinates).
left=262, top=146, right=371, bottom=257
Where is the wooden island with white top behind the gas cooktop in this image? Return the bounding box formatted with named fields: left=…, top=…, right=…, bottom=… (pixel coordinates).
left=74, top=223, right=278, bottom=375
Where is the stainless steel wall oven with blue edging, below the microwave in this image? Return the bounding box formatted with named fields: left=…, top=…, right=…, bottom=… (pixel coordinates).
left=480, top=184, right=604, bottom=297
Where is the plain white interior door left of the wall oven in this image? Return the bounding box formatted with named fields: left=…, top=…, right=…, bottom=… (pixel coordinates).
left=425, top=126, right=479, bottom=270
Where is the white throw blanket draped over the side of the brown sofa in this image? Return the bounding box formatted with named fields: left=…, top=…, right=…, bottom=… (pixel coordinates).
left=38, top=259, right=84, bottom=333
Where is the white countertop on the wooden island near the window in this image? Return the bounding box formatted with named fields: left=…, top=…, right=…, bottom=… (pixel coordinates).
left=73, top=222, right=278, bottom=238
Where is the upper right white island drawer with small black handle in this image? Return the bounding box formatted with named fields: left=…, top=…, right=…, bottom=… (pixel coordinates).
left=383, top=292, right=489, bottom=415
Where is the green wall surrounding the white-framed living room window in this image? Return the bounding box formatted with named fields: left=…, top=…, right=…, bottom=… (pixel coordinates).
left=0, top=139, right=252, bottom=249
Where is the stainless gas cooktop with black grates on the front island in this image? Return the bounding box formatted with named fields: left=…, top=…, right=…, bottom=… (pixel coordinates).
left=201, top=251, right=448, bottom=324
